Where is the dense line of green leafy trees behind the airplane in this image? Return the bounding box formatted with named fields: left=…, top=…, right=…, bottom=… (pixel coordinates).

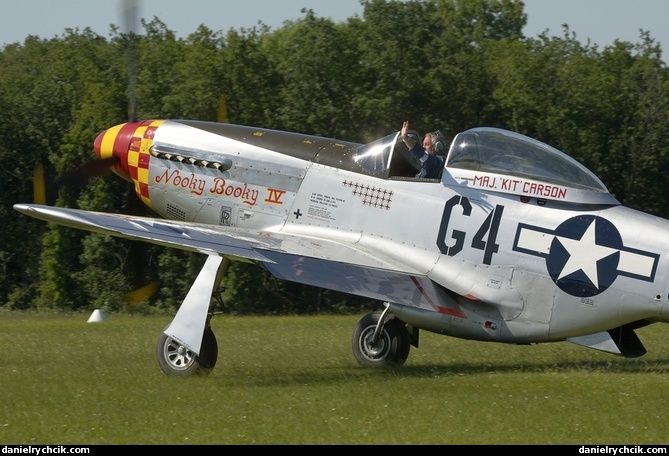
left=0, top=0, right=669, bottom=313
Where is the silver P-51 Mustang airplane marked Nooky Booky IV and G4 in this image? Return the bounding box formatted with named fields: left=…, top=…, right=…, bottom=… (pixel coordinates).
left=14, top=120, right=669, bottom=375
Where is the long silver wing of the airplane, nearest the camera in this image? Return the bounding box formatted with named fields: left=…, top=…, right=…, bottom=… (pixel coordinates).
left=14, top=204, right=461, bottom=314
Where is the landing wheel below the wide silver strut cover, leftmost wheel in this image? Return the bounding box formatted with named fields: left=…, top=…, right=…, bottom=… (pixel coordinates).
left=156, top=327, right=218, bottom=377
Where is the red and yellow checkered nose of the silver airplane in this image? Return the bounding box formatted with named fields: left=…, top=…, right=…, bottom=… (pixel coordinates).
left=93, top=120, right=164, bottom=204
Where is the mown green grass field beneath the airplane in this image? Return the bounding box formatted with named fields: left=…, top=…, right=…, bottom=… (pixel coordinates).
left=0, top=312, right=669, bottom=444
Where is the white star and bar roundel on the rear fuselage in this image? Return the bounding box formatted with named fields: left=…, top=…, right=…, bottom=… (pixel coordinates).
left=513, top=215, right=660, bottom=297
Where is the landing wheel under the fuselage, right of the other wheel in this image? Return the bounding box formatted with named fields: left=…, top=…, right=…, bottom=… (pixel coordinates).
left=351, top=312, right=411, bottom=368
